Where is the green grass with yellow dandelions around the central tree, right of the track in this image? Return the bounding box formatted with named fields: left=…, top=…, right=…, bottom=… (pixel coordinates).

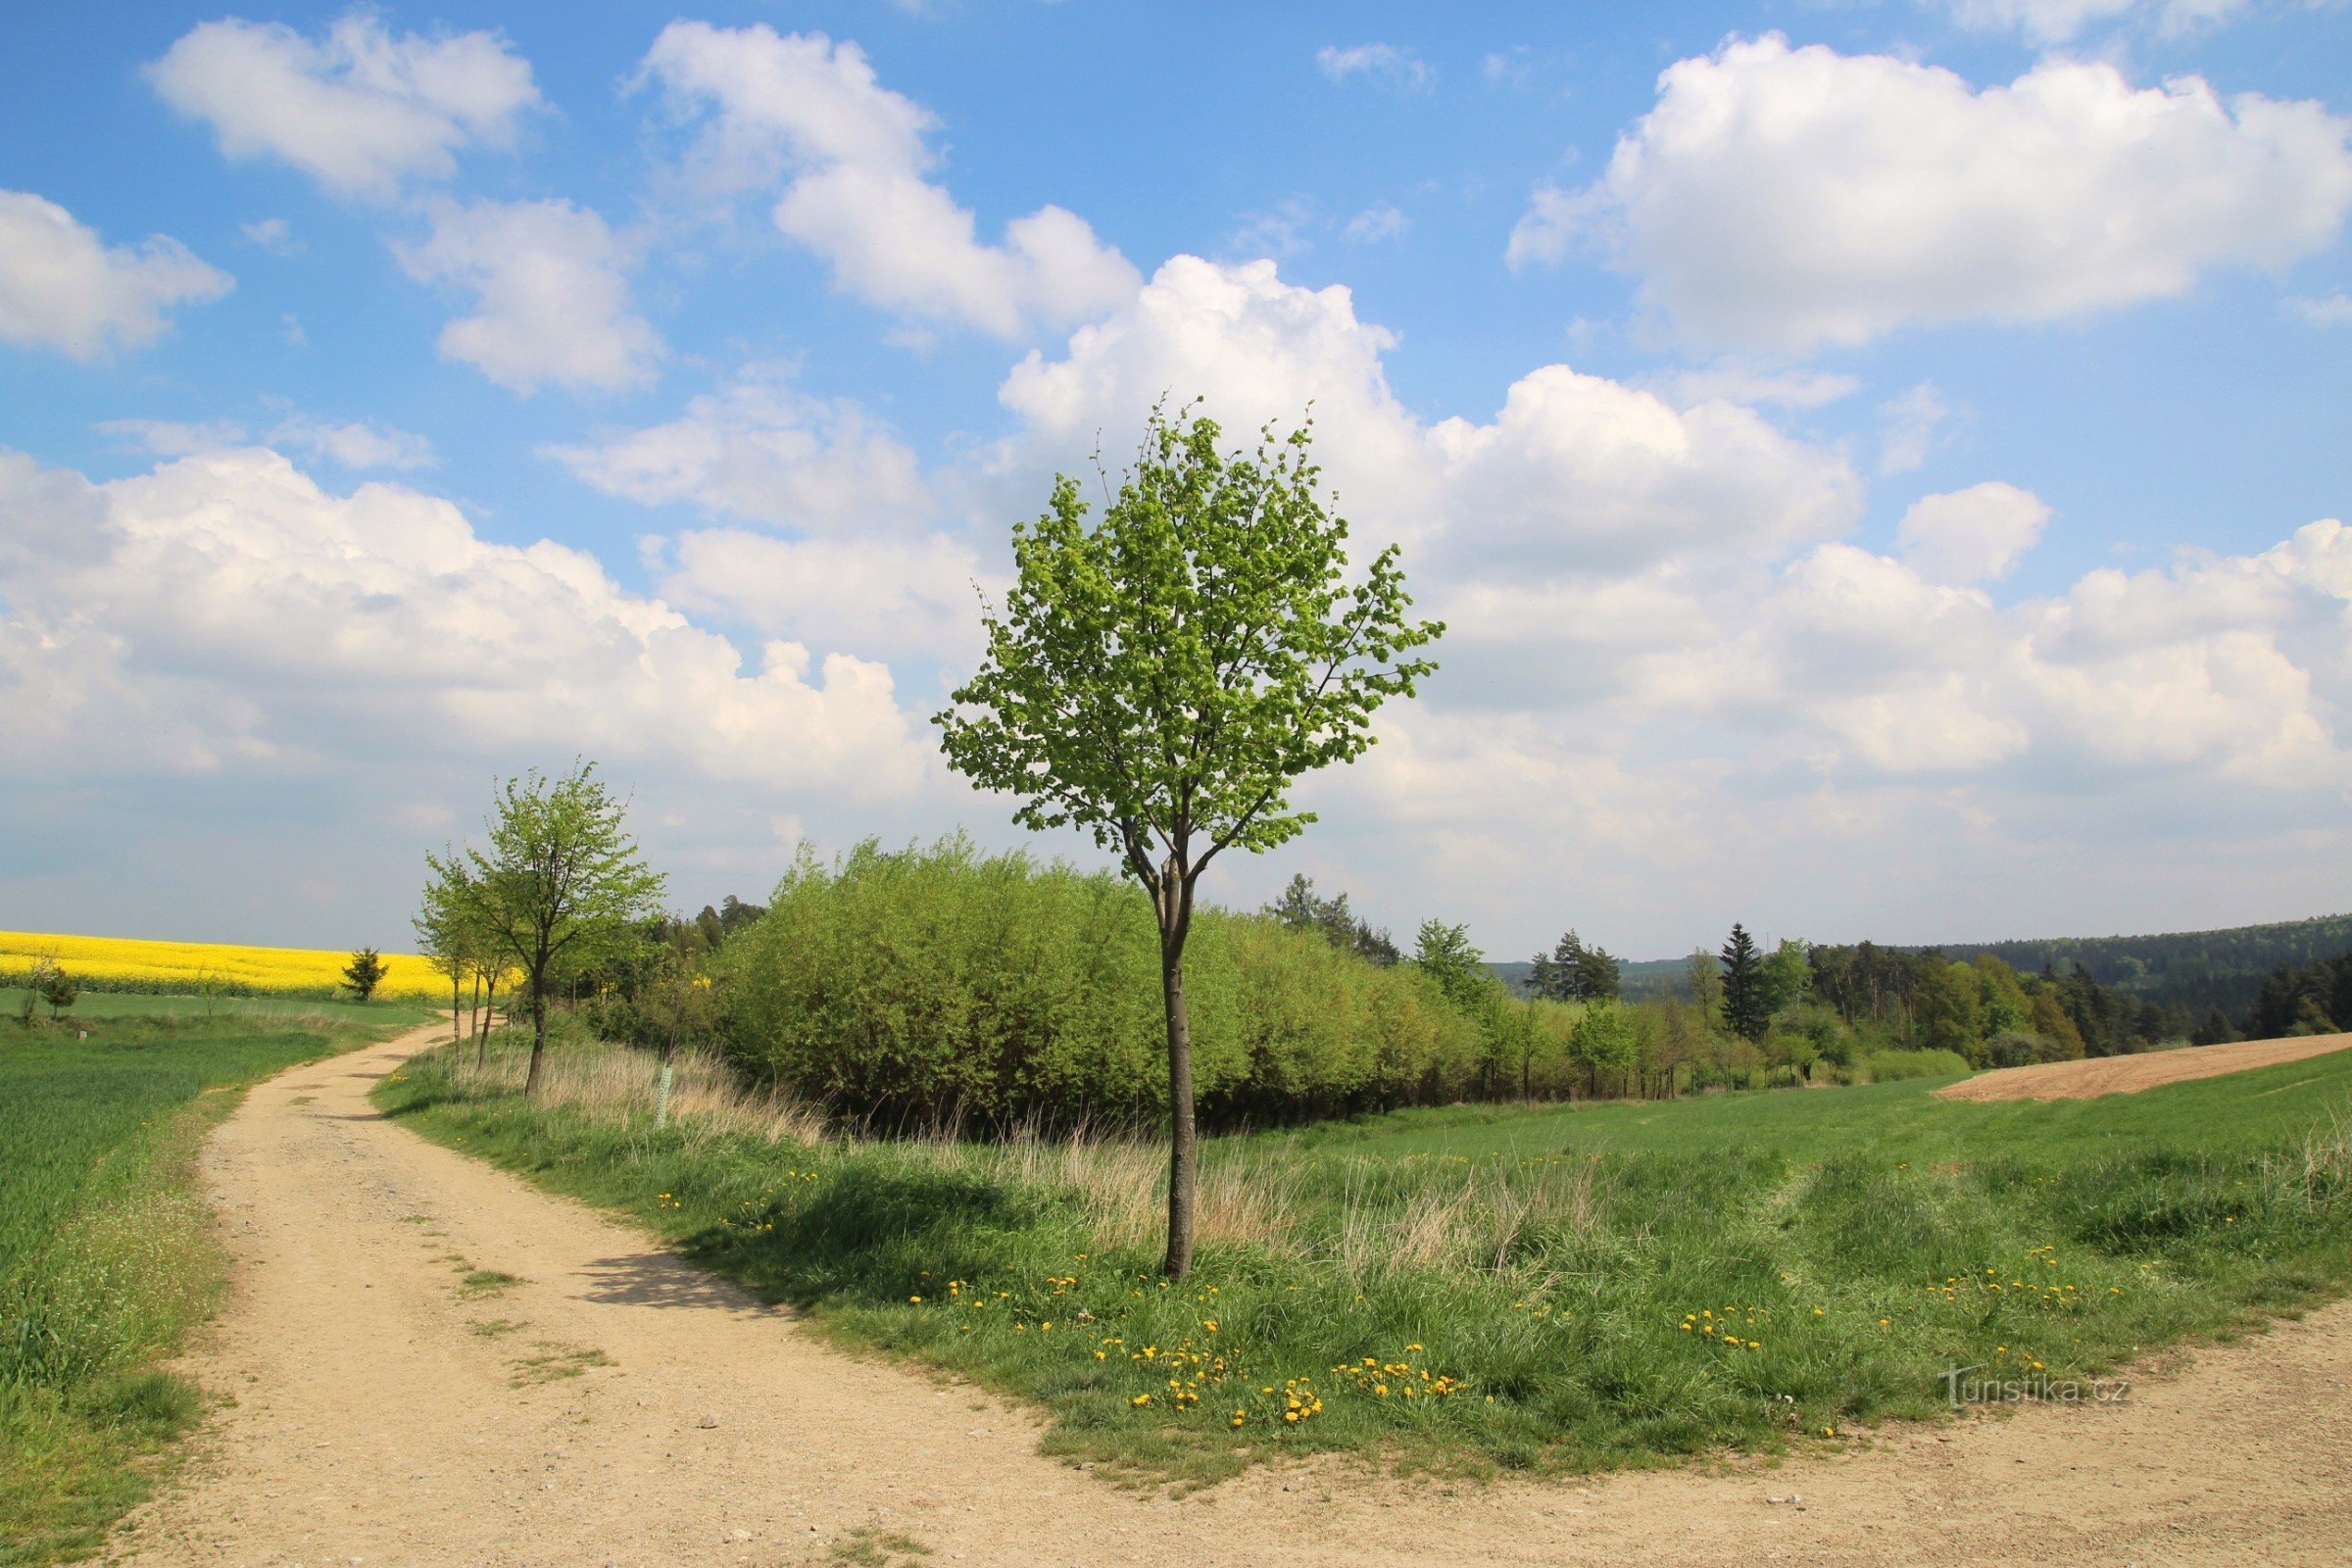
left=378, top=1029, right=2352, bottom=1481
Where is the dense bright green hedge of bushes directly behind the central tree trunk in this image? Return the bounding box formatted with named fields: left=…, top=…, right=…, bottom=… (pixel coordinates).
left=719, top=835, right=1482, bottom=1126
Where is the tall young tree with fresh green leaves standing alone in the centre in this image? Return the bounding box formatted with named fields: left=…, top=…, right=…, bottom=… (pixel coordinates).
left=934, top=409, right=1445, bottom=1277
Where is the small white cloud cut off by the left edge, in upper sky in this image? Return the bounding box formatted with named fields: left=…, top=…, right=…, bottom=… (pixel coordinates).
left=0, top=190, right=233, bottom=360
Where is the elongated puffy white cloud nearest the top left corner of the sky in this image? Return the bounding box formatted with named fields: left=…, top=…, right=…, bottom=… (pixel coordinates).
left=148, top=10, right=541, bottom=200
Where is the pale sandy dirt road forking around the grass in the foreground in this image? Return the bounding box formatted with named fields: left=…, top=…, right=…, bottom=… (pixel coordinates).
left=118, top=1032, right=2352, bottom=1568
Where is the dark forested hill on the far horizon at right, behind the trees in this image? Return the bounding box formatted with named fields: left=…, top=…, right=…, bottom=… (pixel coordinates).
left=1492, top=914, right=2352, bottom=1032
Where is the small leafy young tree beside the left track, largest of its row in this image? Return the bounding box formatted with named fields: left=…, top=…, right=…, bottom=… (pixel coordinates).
left=425, top=761, right=663, bottom=1098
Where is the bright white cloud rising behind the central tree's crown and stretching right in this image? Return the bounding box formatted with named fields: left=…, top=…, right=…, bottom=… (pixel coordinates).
left=1000, top=256, right=1860, bottom=576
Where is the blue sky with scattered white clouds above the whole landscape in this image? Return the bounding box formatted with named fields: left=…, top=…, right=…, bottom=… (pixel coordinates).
left=0, top=0, right=2352, bottom=956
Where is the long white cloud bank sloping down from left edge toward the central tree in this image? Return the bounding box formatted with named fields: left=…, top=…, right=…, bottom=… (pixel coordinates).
left=0, top=449, right=927, bottom=795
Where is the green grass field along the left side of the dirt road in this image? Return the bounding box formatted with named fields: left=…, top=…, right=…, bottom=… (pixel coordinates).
left=0, top=997, right=410, bottom=1568
